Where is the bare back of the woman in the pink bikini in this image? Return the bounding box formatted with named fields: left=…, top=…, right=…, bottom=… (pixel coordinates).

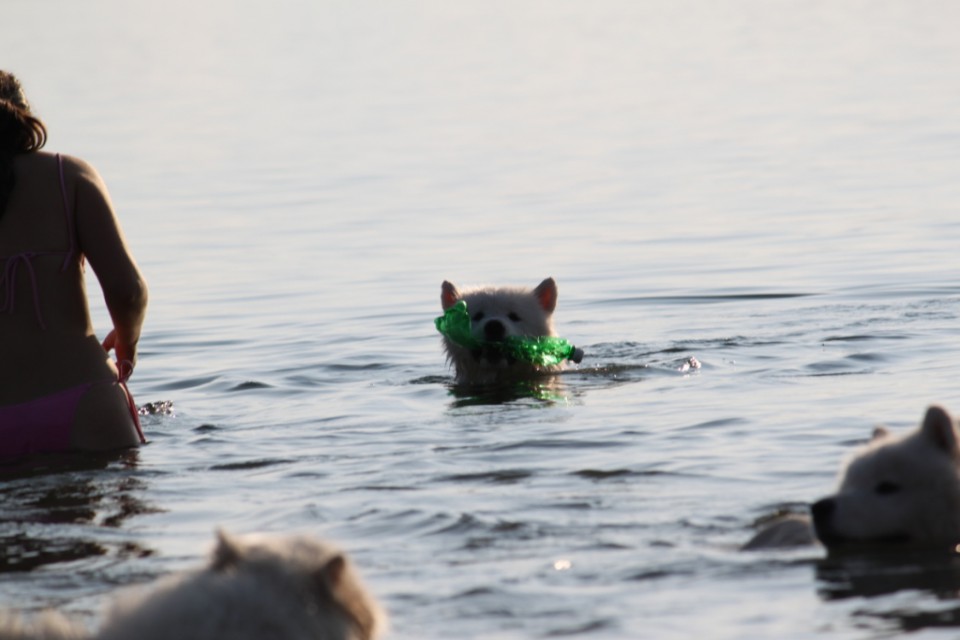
left=0, top=152, right=116, bottom=406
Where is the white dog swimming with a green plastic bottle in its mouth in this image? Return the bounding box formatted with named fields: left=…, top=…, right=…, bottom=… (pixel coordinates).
left=440, top=278, right=562, bottom=385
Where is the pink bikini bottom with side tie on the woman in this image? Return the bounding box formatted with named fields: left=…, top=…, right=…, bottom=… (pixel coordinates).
left=0, top=380, right=146, bottom=457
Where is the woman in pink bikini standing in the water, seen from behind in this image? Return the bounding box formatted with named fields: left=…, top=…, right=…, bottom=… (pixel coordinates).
left=0, top=70, right=147, bottom=456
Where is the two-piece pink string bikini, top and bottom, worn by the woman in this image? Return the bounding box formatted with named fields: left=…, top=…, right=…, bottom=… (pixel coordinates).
left=0, top=154, right=146, bottom=457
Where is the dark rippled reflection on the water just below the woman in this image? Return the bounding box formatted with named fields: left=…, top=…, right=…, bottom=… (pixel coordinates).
left=0, top=449, right=158, bottom=574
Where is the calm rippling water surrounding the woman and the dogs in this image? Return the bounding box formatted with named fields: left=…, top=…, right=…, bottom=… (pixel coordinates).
left=0, top=0, right=960, bottom=638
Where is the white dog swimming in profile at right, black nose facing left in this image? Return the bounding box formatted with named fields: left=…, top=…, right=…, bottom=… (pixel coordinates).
left=744, top=406, right=960, bottom=549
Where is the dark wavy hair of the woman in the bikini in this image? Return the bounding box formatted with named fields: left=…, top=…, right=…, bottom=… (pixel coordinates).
left=0, top=70, right=47, bottom=216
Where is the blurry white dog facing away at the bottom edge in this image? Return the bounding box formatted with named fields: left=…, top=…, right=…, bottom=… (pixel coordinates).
left=0, top=532, right=385, bottom=640
